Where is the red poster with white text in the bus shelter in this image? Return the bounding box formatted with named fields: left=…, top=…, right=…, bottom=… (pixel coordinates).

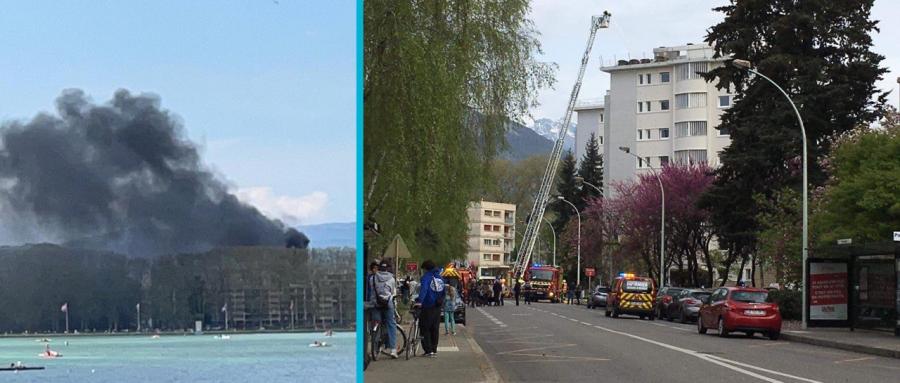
left=809, top=262, right=848, bottom=320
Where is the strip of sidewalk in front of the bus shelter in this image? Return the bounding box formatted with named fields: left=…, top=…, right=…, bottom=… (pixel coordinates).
left=781, top=322, right=900, bottom=358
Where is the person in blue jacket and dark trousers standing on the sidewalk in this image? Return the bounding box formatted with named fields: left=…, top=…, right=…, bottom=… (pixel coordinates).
left=416, top=259, right=447, bottom=358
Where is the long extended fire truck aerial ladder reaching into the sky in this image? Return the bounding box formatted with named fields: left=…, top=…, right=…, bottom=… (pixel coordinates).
left=513, top=11, right=611, bottom=281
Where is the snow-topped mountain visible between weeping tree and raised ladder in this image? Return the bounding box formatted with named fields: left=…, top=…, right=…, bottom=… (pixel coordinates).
left=501, top=118, right=575, bottom=161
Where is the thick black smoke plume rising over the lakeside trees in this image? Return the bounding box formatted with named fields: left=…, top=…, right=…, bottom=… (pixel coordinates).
left=0, top=90, right=306, bottom=256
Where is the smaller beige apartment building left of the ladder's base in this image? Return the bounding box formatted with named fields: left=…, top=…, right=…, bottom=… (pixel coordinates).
left=466, top=201, right=516, bottom=279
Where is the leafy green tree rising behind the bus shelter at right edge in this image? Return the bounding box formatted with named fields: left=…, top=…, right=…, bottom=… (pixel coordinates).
left=813, top=110, right=900, bottom=245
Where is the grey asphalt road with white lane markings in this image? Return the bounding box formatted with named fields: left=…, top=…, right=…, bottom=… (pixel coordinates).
left=468, top=302, right=900, bottom=383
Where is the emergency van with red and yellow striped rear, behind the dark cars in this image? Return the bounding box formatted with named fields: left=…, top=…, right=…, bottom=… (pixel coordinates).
left=605, top=273, right=656, bottom=320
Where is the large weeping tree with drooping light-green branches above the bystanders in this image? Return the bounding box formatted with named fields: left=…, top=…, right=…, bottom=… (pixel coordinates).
left=363, top=0, right=553, bottom=261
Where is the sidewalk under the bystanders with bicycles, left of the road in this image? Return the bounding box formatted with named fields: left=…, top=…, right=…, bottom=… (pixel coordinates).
left=363, top=318, right=501, bottom=383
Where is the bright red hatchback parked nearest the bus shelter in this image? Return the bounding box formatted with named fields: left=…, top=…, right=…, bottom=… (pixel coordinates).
left=697, top=287, right=781, bottom=340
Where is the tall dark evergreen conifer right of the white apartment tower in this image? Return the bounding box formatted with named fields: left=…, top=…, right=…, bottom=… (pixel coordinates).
left=701, top=0, right=885, bottom=268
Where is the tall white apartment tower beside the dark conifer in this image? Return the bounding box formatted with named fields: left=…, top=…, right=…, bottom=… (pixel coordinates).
left=576, top=44, right=732, bottom=196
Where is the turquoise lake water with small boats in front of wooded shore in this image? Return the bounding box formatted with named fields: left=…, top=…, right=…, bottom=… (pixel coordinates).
left=0, top=333, right=356, bottom=383
